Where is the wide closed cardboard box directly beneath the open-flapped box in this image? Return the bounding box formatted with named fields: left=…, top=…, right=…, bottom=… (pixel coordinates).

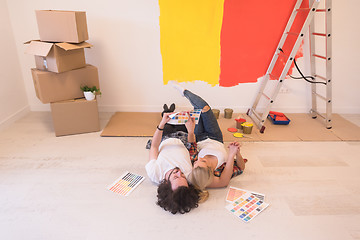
left=31, top=65, right=100, bottom=103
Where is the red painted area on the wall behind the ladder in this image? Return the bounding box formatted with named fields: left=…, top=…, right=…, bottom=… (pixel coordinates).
left=219, top=0, right=308, bottom=87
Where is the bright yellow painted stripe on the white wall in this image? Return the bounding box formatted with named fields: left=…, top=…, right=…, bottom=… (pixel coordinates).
left=159, top=0, right=224, bottom=85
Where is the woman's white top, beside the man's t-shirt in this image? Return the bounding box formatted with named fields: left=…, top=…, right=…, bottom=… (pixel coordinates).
left=197, top=138, right=227, bottom=168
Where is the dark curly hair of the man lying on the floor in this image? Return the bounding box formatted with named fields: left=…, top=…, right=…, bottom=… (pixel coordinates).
left=156, top=179, right=200, bottom=214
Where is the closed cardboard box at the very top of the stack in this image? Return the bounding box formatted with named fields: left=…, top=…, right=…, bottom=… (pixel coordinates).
left=35, top=10, right=89, bottom=43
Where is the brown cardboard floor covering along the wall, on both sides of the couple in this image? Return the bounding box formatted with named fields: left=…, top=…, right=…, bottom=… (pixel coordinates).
left=101, top=112, right=360, bottom=142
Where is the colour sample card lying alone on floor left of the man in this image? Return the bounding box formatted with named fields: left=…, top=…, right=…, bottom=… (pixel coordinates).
left=107, top=172, right=145, bottom=196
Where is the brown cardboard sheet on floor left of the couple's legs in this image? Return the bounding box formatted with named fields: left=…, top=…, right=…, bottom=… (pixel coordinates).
left=101, top=112, right=161, bottom=137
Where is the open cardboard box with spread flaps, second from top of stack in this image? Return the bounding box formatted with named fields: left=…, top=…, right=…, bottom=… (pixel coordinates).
left=25, top=40, right=92, bottom=73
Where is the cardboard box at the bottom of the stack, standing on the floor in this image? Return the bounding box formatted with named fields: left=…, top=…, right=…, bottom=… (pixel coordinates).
left=50, top=98, right=100, bottom=137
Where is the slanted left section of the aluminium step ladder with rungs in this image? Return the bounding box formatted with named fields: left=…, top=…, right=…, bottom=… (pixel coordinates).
left=247, top=0, right=320, bottom=133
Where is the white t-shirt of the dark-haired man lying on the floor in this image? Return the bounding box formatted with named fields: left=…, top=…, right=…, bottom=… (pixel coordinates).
left=145, top=138, right=192, bottom=184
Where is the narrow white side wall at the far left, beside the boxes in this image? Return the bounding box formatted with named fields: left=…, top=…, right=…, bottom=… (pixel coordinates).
left=0, top=0, right=29, bottom=128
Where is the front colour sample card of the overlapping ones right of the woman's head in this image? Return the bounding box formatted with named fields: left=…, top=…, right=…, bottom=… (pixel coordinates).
left=225, top=193, right=269, bottom=222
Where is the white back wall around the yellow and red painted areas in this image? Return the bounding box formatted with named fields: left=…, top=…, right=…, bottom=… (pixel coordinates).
left=2, top=0, right=360, bottom=118
